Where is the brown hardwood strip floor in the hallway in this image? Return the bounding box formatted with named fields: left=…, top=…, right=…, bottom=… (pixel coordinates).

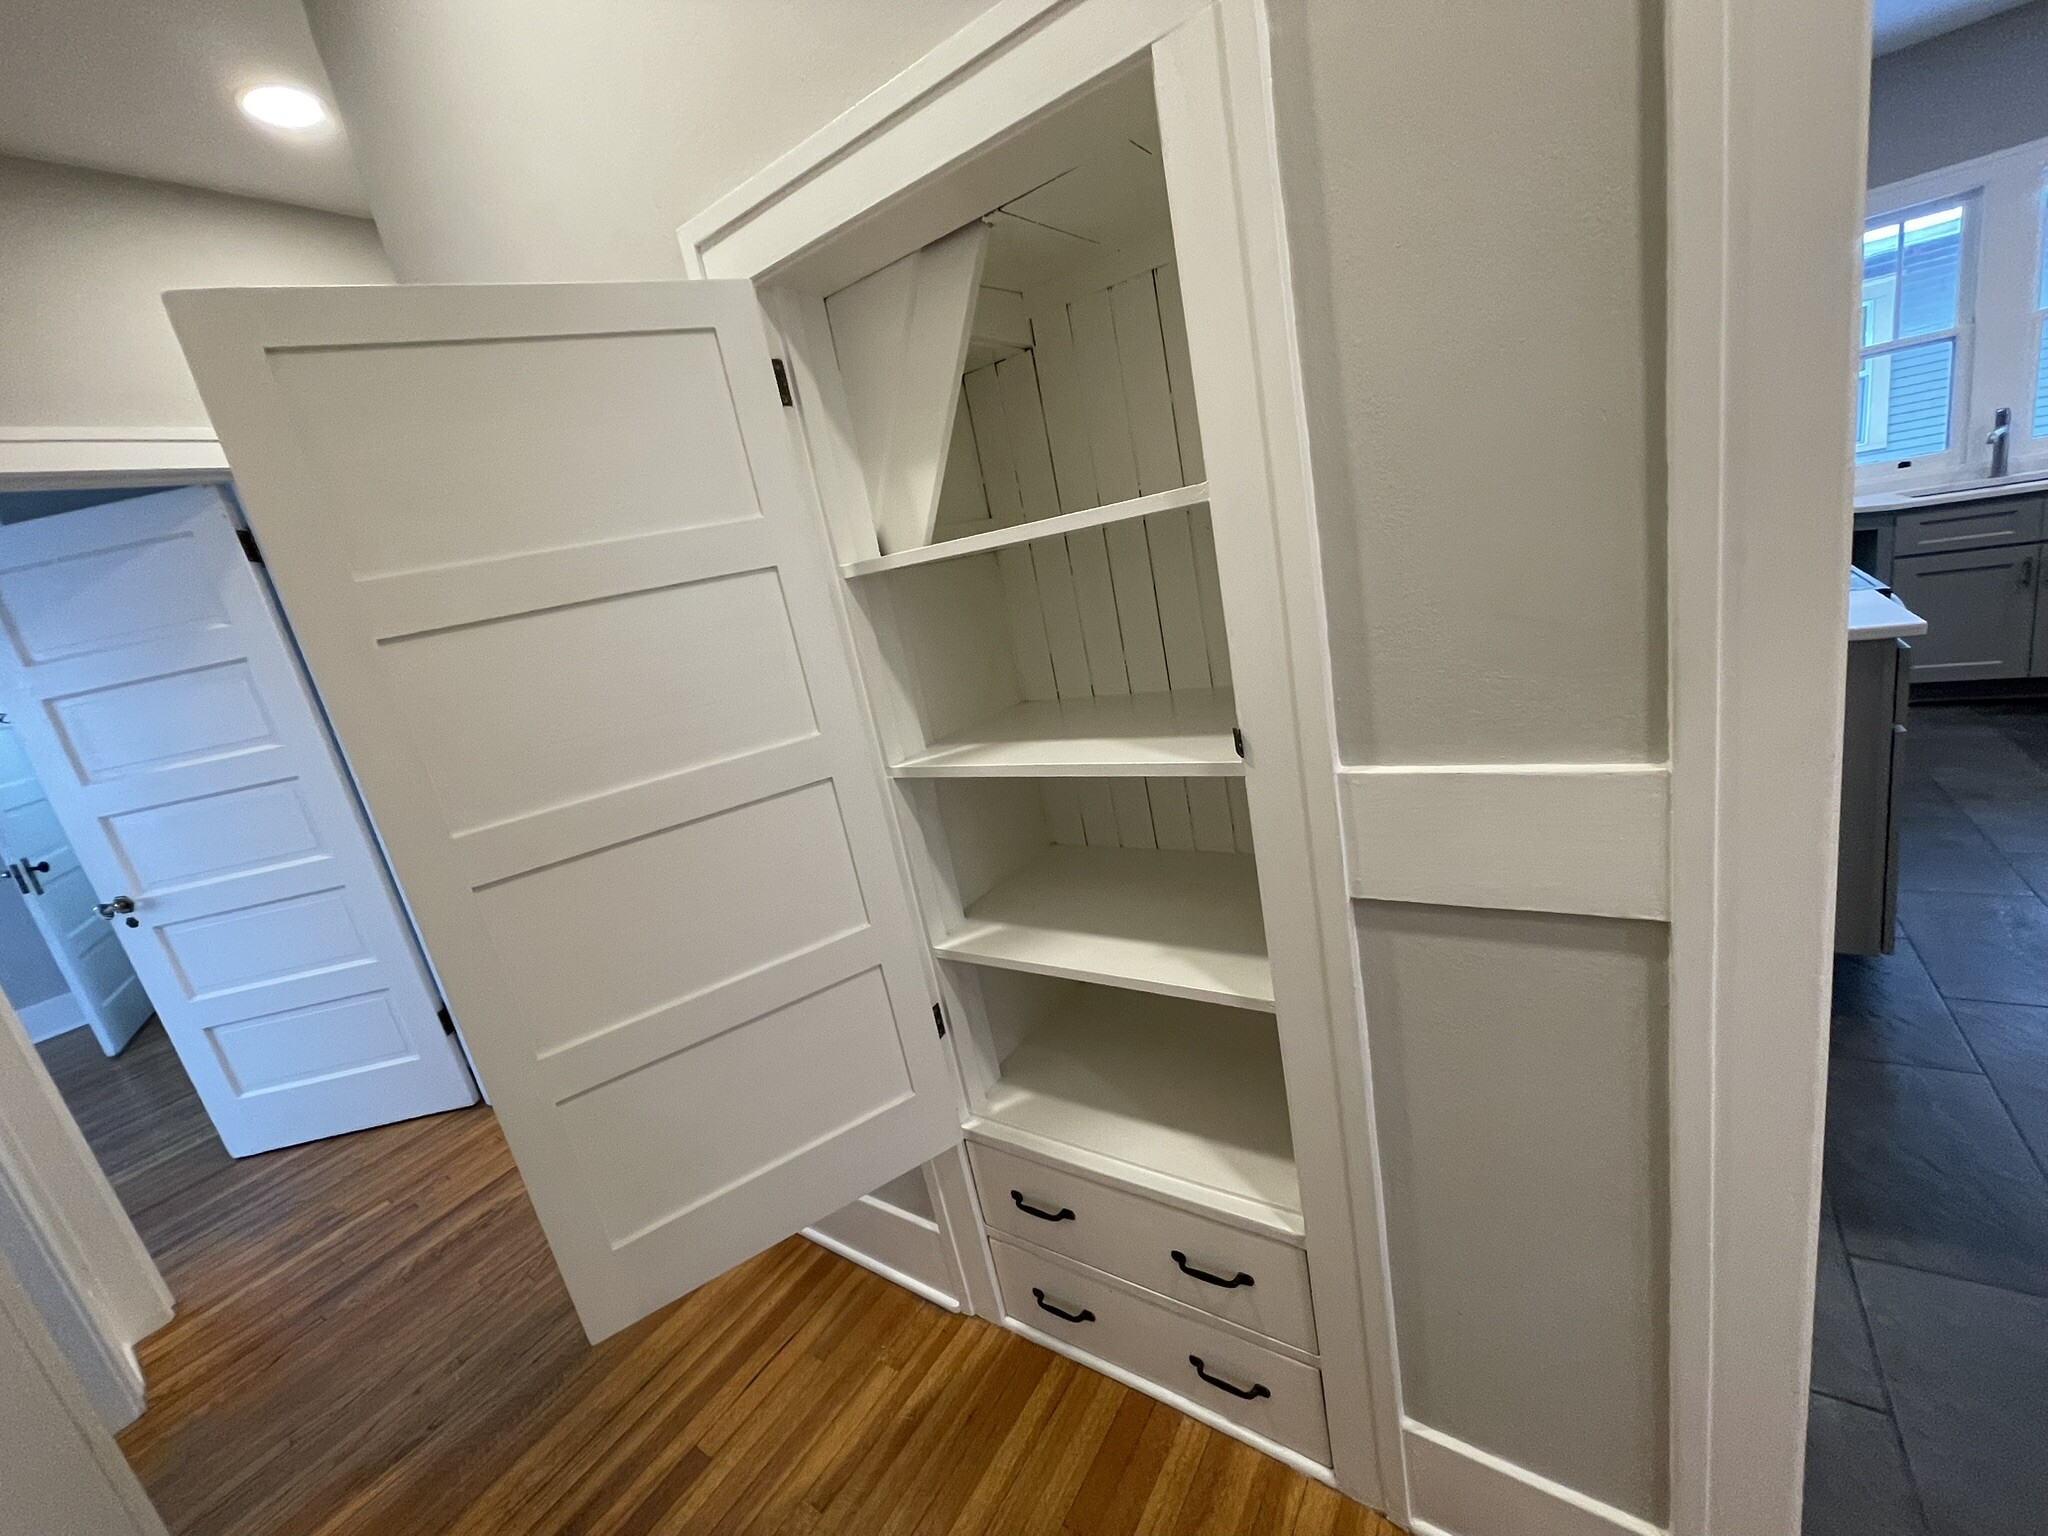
left=43, top=1024, right=1395, bottom=1536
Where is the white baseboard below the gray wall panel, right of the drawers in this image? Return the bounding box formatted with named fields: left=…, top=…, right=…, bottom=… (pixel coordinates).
left=1401, top=1419, right=1665, bottom=1536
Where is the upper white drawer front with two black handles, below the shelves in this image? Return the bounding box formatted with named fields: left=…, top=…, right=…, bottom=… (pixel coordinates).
left=967, top=1143, right=1315, bottom=1352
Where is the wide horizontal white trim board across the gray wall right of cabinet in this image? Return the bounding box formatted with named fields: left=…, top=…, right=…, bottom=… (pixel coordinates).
left=1337, top=762, right=1671, bottom=920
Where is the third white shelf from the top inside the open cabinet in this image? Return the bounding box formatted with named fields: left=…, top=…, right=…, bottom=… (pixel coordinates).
left=934, top=848, right=1274, bottom=1012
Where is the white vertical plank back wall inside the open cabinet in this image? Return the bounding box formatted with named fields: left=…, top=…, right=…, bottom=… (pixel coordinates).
left=938, top=264, right=1251, bottom=868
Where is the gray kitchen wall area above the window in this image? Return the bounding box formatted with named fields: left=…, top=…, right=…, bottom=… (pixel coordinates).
left=1870, top=0, right=2048, bottom=186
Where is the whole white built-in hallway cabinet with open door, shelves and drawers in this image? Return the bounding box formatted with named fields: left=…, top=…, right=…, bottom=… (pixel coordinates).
left=172, top=36, right=1391, bottom=1493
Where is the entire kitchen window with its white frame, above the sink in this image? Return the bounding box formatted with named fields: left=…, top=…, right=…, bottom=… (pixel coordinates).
left=1855, top=139, right=2048, bottom=494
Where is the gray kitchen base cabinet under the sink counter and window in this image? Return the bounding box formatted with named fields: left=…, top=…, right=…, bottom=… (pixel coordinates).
left=1866, top=498, right=2048, bottom=684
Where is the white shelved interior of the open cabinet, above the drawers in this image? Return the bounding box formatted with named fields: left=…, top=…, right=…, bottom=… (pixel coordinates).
left=794, top=70, right=1300, bottom=1235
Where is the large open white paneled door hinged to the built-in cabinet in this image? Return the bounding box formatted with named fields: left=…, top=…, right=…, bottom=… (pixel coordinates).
left=168, top=283, right=958, bottom=1337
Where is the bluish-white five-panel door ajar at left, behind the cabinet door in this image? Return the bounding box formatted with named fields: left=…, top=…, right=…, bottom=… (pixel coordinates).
left=0, top=487, right=475, bottom=1157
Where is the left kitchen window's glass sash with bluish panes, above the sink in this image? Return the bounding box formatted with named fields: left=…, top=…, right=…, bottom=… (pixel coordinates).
left=1855, top=203, right=1966, bottom=463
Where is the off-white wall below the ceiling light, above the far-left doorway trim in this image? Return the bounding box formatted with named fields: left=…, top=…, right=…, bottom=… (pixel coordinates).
left=0, top=156, right=391, bottom=432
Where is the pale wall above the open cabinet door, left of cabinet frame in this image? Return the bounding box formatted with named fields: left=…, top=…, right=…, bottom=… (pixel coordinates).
left=305, top=0, right=993, bottom=283
